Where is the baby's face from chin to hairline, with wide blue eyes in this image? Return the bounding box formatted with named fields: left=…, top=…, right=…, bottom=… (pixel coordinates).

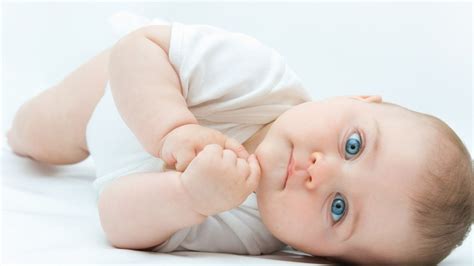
left=255, top=97, right=428, bottom=261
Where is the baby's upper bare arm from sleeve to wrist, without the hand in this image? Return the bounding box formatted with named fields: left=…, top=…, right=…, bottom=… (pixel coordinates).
left=109, top=25, right=198, bottom=157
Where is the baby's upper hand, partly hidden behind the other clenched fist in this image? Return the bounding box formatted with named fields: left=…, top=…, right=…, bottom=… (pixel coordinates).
left=158, top=124, right=249, bottom=172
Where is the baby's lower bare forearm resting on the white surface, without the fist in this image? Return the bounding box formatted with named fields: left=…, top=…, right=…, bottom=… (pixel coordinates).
left=98, top=171, right=206, bottom=249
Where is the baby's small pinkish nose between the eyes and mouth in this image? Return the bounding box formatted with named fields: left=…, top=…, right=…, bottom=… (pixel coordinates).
left=305, top=152, right=335, bottom=189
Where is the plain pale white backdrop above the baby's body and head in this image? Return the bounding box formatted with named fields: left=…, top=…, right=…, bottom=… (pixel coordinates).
left=2, top=2, right=473, bottom=154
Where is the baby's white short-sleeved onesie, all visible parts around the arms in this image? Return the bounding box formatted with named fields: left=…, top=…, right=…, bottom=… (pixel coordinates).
left=86, top=14, right=311, bottom=255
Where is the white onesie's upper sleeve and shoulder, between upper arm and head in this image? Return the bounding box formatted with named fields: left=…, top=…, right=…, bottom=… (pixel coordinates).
left=169, top=22, right=311, bottom=124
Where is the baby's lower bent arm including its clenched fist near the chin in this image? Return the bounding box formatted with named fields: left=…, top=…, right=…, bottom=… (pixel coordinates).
left=99, top=144, right=260, bottom=249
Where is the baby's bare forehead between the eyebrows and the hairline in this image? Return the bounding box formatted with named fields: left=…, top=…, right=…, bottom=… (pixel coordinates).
left=342, top=104, right=432, bottom=257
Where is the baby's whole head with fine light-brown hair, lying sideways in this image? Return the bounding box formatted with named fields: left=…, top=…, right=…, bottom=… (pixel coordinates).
left=255, top=96, right=473, bottom=264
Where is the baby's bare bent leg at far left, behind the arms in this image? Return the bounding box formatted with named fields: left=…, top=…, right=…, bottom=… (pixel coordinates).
left=7, top=49, right=110, bottom=164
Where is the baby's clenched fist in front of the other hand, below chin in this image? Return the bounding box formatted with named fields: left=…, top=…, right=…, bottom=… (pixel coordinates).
left=181, top=144, right=260, bottom=216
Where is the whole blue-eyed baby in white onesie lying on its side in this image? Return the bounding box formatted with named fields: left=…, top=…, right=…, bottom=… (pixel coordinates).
left=8, top=19, right=473, bottom=264
